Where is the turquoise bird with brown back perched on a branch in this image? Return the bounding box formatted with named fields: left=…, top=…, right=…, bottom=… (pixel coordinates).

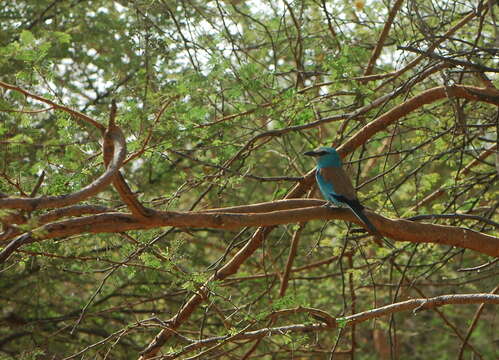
left=304, top=147, right=393, bottom=248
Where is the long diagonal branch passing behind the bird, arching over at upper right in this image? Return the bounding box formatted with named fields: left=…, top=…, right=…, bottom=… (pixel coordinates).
left=140, top=86, right=499, bottom=360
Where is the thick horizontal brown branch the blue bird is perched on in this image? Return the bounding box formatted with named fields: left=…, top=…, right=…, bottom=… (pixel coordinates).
left=0, top=199, right=499, bottom=264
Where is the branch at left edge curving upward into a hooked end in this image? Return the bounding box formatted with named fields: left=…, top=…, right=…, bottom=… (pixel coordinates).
left=0, top=128, right=126, bottom=211
